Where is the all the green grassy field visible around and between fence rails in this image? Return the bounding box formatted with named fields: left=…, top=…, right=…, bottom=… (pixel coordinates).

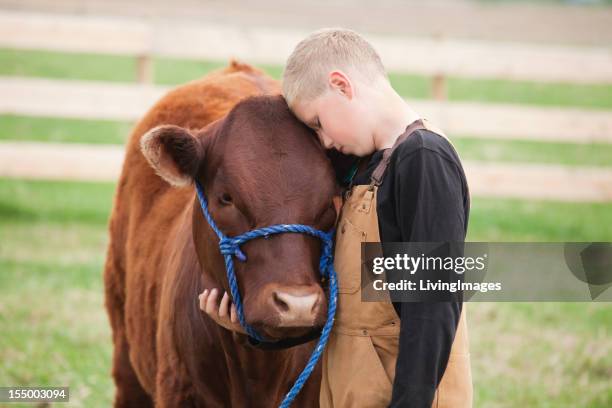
left=0, top=45, right=612, bottom=408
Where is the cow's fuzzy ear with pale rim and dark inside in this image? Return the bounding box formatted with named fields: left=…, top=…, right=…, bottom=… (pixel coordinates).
left=140, top=125, right=204, bottom=187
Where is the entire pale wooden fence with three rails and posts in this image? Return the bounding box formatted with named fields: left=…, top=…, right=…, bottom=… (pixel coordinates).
left=0, top=11, right=612, bottom=201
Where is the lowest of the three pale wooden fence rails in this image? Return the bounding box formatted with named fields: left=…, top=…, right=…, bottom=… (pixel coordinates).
left=0, top=142, right=612, bottom=202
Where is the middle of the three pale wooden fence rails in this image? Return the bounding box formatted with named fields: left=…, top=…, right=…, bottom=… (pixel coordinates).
left=0, top=77, right=612, bottom=143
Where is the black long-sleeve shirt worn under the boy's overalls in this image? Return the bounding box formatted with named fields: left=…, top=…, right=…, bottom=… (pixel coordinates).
left=353, top=130, right=470, bottom=408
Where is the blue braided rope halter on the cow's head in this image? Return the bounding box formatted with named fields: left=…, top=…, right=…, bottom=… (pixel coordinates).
left=195, top=180, right=338, bottom=408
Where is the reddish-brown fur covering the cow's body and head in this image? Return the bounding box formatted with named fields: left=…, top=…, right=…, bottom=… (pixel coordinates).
left=104, top=62, right=335, bottom=407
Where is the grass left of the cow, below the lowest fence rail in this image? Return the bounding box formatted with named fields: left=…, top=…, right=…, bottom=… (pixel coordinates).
left=0, top=180, right=114, bottom=407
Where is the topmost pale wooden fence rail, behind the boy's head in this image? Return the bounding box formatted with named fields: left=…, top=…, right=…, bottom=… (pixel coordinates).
left=0, top=11, right=612, bottom=92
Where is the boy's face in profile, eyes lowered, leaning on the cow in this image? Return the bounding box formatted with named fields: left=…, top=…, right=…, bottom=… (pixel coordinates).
left=293, top=71, right=375, bottom=156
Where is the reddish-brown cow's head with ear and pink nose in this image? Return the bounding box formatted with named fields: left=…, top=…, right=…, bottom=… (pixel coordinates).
left=142, top=96, right=337, bottom=339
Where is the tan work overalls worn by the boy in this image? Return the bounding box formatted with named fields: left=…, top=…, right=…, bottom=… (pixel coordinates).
left=319, top=120, right=472, bottom=408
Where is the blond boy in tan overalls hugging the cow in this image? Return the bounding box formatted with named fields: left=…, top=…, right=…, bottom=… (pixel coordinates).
left=201, top=29, right=472, bottom=408
